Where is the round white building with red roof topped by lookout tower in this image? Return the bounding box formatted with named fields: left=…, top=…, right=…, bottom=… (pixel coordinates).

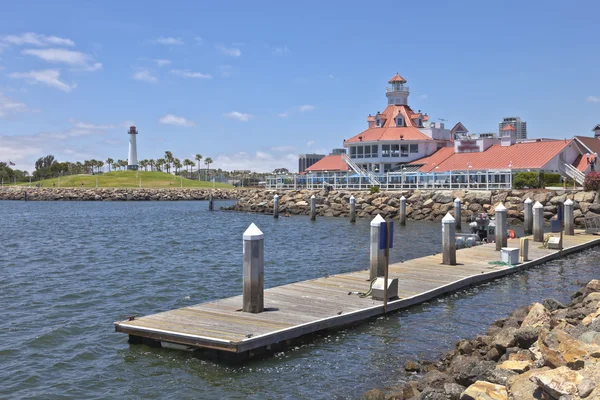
left=344, top=74, right=452, bottom=174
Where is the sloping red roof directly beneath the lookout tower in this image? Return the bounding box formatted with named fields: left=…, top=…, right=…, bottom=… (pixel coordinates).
left=346, top=105, right=432, bottom=143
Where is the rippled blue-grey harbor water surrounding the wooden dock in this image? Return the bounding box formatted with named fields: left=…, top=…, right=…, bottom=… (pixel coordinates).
left=0, top=202, right=600, bottom=399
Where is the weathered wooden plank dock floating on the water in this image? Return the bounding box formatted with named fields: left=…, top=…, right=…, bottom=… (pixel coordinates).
left=115, top=231, right=600, bottom=353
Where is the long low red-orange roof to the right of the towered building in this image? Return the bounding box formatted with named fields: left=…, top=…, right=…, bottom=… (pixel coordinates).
left=410, top=140, right=572, bottom=172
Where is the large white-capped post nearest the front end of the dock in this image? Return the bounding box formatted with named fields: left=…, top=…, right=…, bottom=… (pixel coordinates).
left=242, top=223, right=265, bottom=313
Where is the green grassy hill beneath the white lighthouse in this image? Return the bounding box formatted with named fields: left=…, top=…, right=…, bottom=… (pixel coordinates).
left=21, top=171, right=233, bottom=188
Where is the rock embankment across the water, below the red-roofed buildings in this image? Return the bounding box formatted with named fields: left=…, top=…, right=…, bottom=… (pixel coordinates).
left=229, top=190, right=600, bottom=227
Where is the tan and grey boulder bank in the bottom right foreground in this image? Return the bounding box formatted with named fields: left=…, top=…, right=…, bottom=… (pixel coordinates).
left=362, top=280, right=600, bottom=400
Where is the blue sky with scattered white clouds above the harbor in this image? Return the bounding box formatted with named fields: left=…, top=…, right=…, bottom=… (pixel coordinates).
left=0, top=0, right=600, bottom=172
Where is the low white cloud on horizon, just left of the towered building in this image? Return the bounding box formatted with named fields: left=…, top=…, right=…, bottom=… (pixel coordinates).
left=211, top=151, right=298, bottom=172
